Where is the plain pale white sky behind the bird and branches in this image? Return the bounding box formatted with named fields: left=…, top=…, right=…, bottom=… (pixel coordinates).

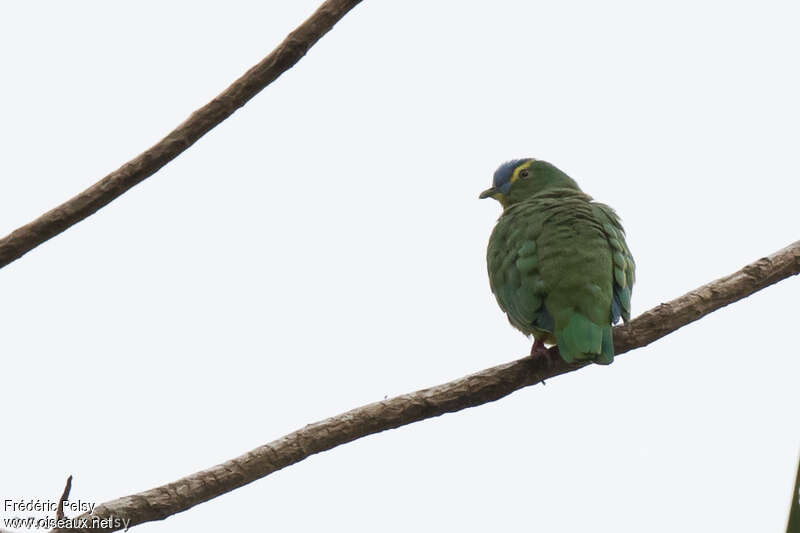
left=0, top=0, right=800, bottom=532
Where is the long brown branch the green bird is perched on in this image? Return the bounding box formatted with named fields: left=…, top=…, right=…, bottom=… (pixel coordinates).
left=51, top=241, right=800, bottom=532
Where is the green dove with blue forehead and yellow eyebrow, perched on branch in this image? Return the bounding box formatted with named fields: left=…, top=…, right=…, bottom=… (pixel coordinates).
left=480, top=158, right=635, bottom=364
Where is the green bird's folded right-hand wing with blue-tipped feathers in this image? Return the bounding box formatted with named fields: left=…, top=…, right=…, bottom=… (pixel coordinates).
left=592, top=202, right=636, bottom=324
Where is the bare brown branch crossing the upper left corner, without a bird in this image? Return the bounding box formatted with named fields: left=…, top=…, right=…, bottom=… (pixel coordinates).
left=0, top=0, right=361, bottom=268
